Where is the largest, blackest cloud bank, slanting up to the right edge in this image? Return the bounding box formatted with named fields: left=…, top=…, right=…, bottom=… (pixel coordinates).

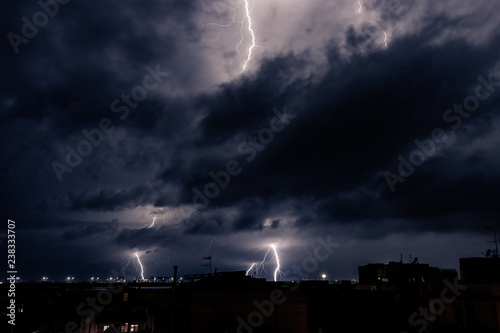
left=166, top=23, right=500, bottom=230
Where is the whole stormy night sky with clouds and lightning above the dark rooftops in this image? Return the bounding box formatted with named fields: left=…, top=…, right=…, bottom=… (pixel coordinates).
left=0, top=0, right=500, bottom=281
